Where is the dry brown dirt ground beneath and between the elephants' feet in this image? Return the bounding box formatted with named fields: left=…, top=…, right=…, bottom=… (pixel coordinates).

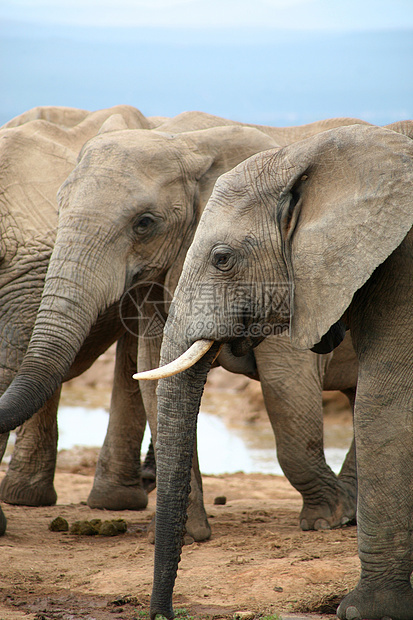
left=0, top=346, right=359, bottom=620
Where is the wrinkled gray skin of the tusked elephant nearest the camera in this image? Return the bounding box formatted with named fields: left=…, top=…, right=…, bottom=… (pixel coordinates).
left=151, top=126, right=413, bottom=620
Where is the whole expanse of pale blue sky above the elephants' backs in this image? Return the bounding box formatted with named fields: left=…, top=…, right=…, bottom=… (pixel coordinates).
left=0, top=0, right=413, bottom=125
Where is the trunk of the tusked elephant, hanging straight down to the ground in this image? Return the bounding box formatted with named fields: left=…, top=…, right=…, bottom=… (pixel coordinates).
left=151, top=329, right=219, bottom=619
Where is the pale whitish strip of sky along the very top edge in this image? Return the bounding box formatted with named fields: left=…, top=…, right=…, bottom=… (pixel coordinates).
left=0, top=0, right=413, bottom=31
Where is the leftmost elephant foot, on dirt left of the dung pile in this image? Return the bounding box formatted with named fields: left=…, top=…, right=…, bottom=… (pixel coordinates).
left=0, top=469, right=57, bottom=506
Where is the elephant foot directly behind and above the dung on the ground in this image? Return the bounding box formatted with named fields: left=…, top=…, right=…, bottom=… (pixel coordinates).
left=87, top=478, right=148, bottom=510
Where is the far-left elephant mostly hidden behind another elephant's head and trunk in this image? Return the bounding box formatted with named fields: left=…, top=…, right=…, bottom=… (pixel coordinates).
left=0, top=106, right=151, bottom=533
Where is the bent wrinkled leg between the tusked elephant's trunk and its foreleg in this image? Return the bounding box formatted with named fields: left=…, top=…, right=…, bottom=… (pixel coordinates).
left=255, top=336, right=356, bottom=530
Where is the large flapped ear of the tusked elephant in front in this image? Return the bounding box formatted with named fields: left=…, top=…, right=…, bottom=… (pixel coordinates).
left=269, top=125, right=413, bottom=349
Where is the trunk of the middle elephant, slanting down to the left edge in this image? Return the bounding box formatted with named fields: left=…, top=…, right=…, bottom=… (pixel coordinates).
left=0, top=235, right=123, bottom=433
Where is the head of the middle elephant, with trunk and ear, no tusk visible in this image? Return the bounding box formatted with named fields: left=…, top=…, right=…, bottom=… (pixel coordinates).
left=0, top=119, right=276, bottom=432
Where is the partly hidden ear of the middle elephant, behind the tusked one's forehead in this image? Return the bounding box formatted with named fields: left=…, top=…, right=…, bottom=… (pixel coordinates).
left=165, top=125, right=278, bottom=296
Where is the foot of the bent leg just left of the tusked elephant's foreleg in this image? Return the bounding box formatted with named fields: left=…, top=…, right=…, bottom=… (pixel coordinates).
left=300, top=490, right=356, bottom=532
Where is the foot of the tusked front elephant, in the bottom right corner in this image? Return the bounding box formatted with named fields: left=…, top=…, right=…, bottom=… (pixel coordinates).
left=337, top=584, right=413, bottom=620
